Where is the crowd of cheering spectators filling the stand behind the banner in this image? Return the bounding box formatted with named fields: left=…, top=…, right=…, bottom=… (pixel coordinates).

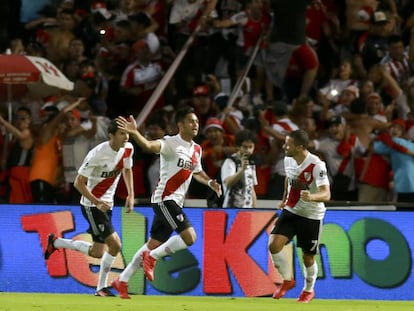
left=0, top=0, right=414, bottom=204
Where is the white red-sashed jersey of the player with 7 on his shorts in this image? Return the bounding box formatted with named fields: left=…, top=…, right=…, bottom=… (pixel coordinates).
left=285, top=152, right=329, bottom=219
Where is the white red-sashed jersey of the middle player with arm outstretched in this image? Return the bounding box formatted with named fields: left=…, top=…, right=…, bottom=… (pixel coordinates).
left=151, top=134, right=202, bottom=207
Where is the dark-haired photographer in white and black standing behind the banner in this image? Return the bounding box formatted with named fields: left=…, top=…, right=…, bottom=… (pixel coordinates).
left=221, top=130, right=257, bottom=208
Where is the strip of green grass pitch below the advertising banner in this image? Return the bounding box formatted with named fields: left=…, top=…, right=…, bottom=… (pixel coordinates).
left=0, top=292, right=414, bottom=311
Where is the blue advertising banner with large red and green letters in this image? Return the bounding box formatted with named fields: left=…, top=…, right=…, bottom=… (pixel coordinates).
left=0, top=205, right=414, bottom=300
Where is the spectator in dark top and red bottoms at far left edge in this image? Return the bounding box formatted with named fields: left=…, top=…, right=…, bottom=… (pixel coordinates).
left=0, top=107, right=35, bottom=203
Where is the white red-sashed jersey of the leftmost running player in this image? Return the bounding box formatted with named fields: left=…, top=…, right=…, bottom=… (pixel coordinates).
left=78, top=141, right=134, bottom=206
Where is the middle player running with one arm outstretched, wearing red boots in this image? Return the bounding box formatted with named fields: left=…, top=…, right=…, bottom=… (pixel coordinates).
left=112, top=107, right=221, bottom=299
